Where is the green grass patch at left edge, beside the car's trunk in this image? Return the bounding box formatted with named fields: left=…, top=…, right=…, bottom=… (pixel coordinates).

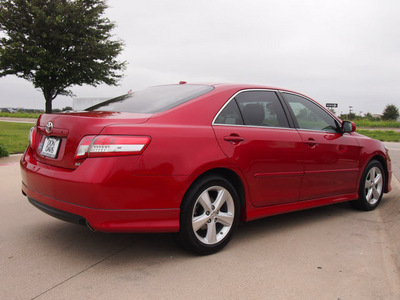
left=0, top=122, right=34, bottom=154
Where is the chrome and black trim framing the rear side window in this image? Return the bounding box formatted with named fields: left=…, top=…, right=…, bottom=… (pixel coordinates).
left=211, top=89, right=296, bottom=129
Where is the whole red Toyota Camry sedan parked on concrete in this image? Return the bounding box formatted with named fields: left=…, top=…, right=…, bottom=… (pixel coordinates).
left=21, top=83, right=391, bottom=254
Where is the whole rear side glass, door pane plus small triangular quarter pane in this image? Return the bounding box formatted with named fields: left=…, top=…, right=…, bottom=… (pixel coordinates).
left=215, top=91, right=289, bottom=127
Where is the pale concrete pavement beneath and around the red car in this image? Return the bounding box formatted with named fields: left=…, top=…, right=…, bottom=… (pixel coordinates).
left=0, top=143, right=400, bottom=299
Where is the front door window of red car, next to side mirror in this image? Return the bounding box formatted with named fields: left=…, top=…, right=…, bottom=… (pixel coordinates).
left=284, top=93, right=337, bottom=132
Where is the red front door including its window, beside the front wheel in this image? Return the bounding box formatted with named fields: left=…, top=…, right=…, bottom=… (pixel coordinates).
left=282, top=93, right=361, bottom=200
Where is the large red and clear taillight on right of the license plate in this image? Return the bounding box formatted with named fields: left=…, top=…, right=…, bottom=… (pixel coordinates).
left=75, top=135, right=150, bottom=159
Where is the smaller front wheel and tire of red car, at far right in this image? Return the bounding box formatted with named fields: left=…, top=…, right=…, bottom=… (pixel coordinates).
left=350, top=160, right=386, bottom=211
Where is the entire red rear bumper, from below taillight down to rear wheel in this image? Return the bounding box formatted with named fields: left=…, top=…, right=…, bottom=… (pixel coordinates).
left=21, top=148, right=184, bottom=232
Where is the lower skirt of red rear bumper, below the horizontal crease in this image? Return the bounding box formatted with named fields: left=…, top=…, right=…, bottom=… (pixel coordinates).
left=22, top=184, right=180, bottom=232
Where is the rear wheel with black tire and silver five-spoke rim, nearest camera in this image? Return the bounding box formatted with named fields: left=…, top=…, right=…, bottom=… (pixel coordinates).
left=177, top=175, right=240, bottom=255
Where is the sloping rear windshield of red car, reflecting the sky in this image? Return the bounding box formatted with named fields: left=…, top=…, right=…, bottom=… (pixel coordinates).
left=85, top=84, right=214, bottom=114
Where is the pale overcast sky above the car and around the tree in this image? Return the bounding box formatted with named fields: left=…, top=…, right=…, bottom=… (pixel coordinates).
left=0, top=0, right=400, bottom=114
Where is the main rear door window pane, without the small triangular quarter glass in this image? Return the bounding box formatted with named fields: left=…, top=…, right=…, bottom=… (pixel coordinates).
left=235, top=91, right=289, bottom=127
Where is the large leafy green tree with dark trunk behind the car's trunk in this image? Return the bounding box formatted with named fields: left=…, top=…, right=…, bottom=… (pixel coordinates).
left=0, top=0, right=126, bottom=113
